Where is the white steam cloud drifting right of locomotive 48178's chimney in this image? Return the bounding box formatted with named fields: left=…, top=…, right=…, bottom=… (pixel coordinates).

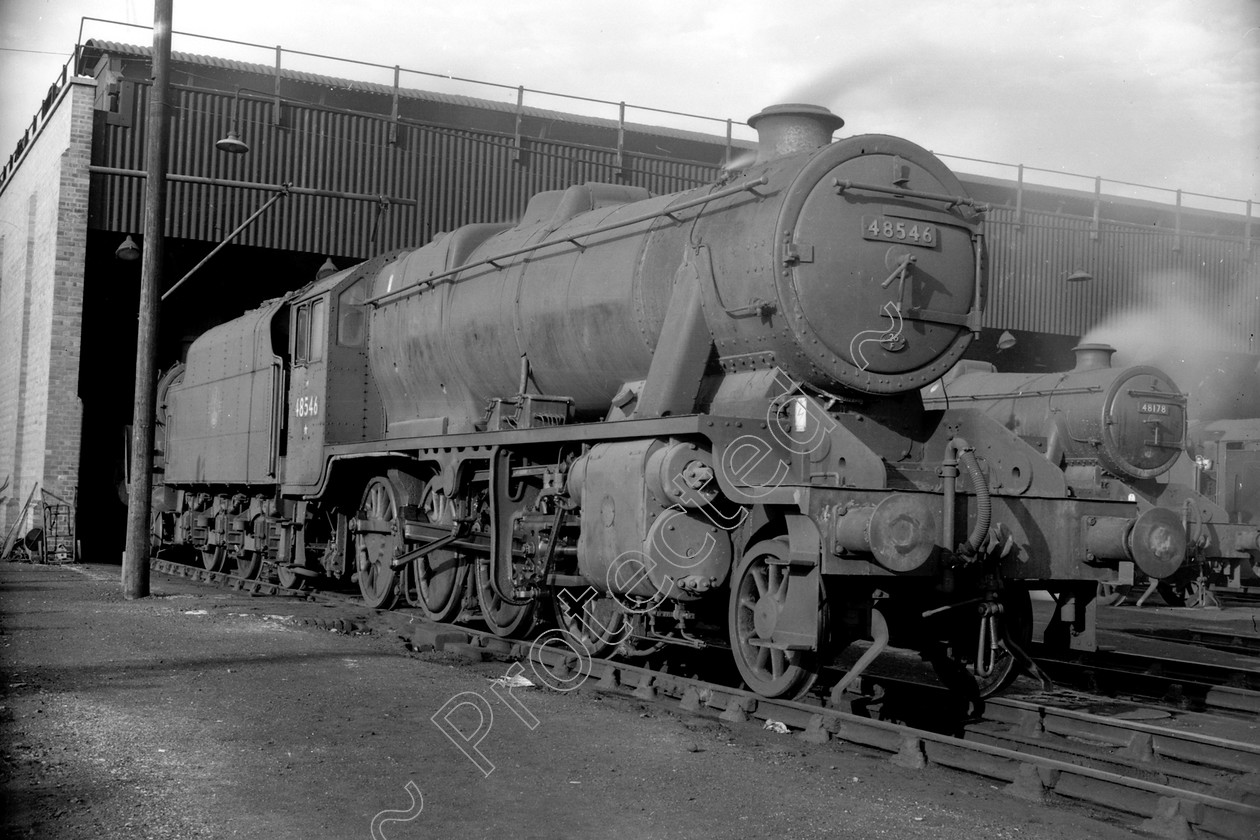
left=1081, top=272, right=1260, bottom=422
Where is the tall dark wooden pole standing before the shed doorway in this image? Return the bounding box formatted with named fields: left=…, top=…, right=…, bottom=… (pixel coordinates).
left=122, top=0, right=174, bottom=599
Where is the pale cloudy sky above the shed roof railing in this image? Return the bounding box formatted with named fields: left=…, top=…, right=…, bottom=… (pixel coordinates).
left=0, top=0, right=1260, bottom=212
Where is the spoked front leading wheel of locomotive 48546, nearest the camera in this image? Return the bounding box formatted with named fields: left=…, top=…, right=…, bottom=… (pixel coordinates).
left=728, top=540, right=818, bottom=698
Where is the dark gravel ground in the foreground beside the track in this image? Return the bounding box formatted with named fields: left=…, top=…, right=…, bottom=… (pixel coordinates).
left=0, top=563, right=1149, bottom=840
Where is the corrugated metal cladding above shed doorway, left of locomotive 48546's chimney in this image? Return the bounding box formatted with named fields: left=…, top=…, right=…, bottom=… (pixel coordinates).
left=92, top=84, right=716, bottom=257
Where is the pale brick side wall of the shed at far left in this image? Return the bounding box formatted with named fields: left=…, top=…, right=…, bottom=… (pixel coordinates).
left=0, top=79, right=96, bottom=549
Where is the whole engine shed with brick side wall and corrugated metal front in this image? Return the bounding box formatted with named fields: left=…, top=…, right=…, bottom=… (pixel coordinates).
left=0, top=29, right=1260, bottom=559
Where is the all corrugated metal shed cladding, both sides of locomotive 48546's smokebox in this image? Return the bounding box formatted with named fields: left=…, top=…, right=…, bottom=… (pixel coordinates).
left=91, top=84, right=1260, bottom=353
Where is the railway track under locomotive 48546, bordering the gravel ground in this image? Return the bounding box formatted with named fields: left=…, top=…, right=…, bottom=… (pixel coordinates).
left=152, top=560, right=1260, bottom=840
